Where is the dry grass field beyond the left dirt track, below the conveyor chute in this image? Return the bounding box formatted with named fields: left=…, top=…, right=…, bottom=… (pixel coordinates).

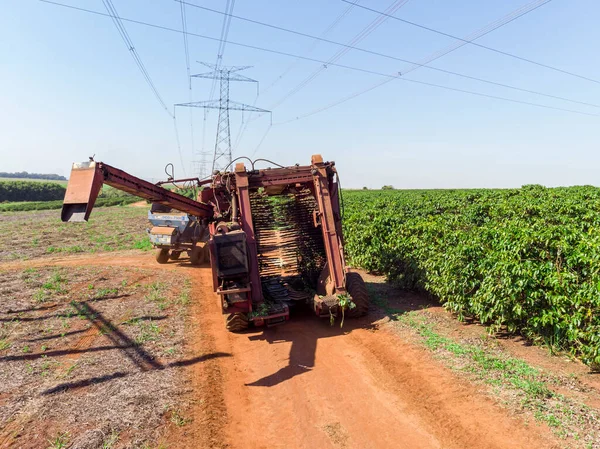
left=0, top=206, right=151, bottom=261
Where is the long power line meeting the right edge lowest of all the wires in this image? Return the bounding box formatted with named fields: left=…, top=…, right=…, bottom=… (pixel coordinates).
left=39, top=0, right=598, bottom=120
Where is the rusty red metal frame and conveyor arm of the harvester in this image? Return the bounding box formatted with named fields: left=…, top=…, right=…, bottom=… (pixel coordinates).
left=62, top=155, right=346, bottom=323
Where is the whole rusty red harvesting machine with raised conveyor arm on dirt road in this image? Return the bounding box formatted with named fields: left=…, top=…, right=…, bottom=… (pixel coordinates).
left=61, top=155, right=369, bottom=331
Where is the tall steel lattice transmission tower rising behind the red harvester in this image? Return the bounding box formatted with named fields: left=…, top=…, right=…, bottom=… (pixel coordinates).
left=175, top=61, right=271, bottom=172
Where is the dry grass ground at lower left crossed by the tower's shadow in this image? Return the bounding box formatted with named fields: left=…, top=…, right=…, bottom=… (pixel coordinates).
left=0, top=267, right=195, bottom=449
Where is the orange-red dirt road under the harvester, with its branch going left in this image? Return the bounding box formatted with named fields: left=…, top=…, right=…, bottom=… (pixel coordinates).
left=0, top=253, right=556, bottom=449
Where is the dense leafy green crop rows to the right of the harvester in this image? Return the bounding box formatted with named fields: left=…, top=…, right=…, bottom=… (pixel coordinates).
left=344, top=185, right=600, bottom=366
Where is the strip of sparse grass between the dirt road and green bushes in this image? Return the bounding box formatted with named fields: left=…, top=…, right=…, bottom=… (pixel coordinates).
left=367, top=285, right=600, bottom=448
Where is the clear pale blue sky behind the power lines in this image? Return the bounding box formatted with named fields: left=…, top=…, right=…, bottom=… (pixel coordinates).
left=0, top=0, right=600, bottom=188
